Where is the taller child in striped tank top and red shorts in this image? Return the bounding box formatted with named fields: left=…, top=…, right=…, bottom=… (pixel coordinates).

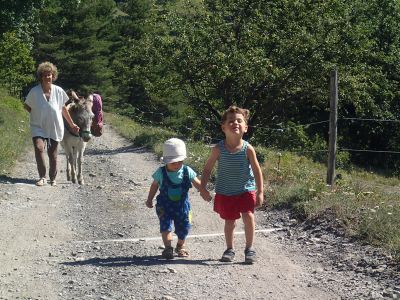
left=201, top=106, right=264, bottom=264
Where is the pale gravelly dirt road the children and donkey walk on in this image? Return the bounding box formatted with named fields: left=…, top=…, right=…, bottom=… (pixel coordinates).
left=0, top=126, right=399, bottom=299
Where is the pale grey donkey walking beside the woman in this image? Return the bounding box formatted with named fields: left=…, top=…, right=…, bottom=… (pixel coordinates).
left=61, top=97, right=94, bottom=185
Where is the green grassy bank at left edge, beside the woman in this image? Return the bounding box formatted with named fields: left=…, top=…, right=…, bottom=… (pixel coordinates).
left=0, top=89, right=31, bottom=175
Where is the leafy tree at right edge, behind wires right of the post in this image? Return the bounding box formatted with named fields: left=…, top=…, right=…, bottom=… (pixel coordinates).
left=332, top=0, right=400, bottom=169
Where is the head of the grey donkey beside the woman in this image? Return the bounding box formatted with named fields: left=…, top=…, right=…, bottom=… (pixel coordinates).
left=69, top=97, right=94, bottom=142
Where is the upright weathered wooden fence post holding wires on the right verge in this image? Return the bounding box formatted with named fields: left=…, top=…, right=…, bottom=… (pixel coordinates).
left=326, top=69, right=338, bottom=186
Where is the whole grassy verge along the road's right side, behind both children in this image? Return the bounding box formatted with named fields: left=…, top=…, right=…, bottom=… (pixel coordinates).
left=105, top=114, right=400, bottom=261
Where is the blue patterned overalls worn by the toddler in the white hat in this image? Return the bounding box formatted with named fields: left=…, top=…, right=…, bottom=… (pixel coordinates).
left=156, top=166, right=192, bottom=240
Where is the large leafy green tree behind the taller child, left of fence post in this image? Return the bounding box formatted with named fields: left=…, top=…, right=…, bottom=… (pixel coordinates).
left=135, top=0, right=356, bottom=135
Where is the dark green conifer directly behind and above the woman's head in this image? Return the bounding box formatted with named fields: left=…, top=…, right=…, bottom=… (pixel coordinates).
left=35, top=0, right=116, bottom=101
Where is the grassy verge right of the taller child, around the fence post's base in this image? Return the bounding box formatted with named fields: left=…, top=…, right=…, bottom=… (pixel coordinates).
left=267, top=152, right=400, bottom=255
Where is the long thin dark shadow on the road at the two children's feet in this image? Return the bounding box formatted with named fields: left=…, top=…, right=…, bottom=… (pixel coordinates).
left=61, top=255, right=214, bottom=267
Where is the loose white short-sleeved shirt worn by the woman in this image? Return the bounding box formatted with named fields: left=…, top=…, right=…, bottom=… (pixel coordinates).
left=25, top=84, right=68, bottom=141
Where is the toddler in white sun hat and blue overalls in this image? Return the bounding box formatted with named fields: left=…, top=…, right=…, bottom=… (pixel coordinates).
left=146, top=138, right=211, bottom=259
